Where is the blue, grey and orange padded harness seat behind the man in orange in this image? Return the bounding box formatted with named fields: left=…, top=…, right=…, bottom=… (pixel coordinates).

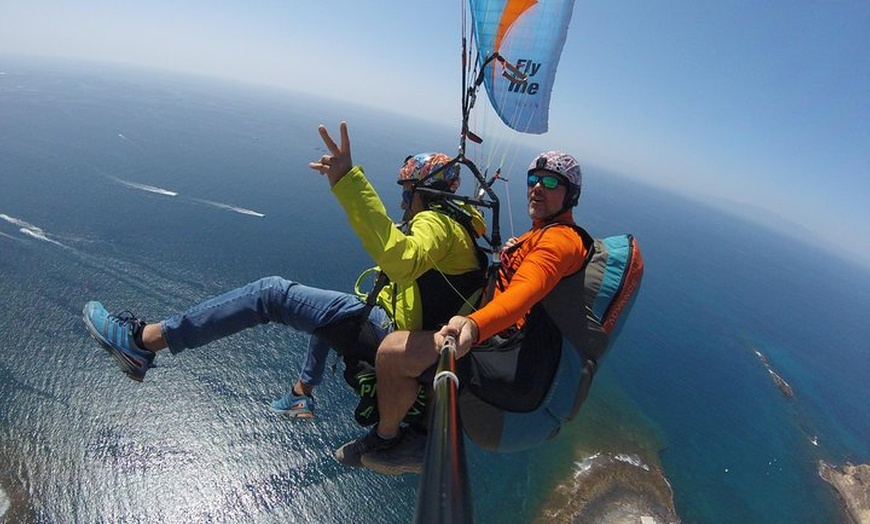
left=458, top=231, right=643, bottom=452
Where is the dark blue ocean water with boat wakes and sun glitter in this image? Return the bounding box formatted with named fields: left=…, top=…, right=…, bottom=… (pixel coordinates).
left=0, top=57, right=870, bottom=523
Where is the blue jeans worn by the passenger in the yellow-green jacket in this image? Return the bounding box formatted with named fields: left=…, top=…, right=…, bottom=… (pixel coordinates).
left=160, top=277, right=393, bottom=386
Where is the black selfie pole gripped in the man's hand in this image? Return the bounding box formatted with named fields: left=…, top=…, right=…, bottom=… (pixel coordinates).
left=414, top=337, right=474, bottom=524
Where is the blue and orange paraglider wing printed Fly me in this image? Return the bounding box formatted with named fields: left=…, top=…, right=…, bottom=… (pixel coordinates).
left=469, top=0, right=574, bottom=134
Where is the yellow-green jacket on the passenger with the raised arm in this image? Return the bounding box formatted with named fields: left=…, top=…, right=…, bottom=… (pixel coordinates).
left=332, top=166, right=485, bottom=330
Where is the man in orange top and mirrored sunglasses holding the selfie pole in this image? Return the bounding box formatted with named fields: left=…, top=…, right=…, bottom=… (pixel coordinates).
left=335, top=151, right=589, bottom=473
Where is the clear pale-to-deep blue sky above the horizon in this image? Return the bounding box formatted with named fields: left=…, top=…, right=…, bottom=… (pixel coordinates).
left=0, top=0, right=870, bottom=266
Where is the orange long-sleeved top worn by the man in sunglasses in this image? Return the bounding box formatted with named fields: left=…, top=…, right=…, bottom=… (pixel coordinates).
left=468, top=210, right=587, bottom=343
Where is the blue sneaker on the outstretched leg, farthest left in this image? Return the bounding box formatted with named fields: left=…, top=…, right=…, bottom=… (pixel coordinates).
left=82, top=301, right=154, bottom=382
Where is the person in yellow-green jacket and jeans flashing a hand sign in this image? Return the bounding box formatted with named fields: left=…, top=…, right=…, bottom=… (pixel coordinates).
left=83, top=122, right=485, bottom=418
